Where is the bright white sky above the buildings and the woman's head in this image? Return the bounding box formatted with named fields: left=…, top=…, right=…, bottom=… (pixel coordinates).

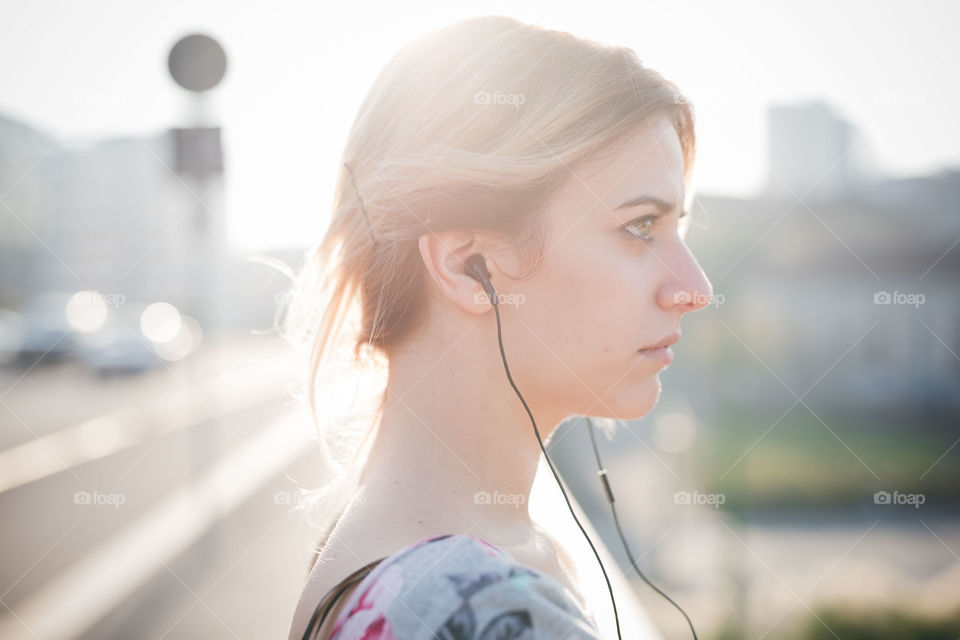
left=0, top=0, right=960, bottom=249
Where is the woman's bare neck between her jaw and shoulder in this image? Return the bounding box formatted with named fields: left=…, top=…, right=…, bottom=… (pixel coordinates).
left=360, top=318, right=559, bottom=543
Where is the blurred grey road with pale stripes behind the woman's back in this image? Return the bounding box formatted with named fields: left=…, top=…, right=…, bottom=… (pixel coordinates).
left=0, top=338, right=330, bottom=639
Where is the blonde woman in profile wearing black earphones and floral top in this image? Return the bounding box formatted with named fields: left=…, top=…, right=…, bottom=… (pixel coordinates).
left=289, top=16, right=712, bottom=640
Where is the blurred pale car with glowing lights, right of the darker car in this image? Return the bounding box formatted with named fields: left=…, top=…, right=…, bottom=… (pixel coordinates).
left=76, top=318, right=162, bottom=376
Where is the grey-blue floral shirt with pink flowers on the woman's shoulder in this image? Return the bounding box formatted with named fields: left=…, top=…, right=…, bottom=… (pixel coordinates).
left=330, top=534, right=600, bottom=640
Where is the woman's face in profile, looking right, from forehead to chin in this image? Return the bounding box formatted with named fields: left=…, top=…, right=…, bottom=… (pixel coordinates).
left=494, top=117, right=712, bottom=419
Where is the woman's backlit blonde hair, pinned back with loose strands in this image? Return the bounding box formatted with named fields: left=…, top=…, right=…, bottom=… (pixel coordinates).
left=285, top=16, right=695, bottom=564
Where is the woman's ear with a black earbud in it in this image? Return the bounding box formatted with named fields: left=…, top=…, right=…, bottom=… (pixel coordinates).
left=419, top=231, right=493, bottom=313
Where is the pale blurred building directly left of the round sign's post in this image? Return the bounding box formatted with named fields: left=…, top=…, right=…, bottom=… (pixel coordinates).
left=39, top=137, right=191, bottom=303
